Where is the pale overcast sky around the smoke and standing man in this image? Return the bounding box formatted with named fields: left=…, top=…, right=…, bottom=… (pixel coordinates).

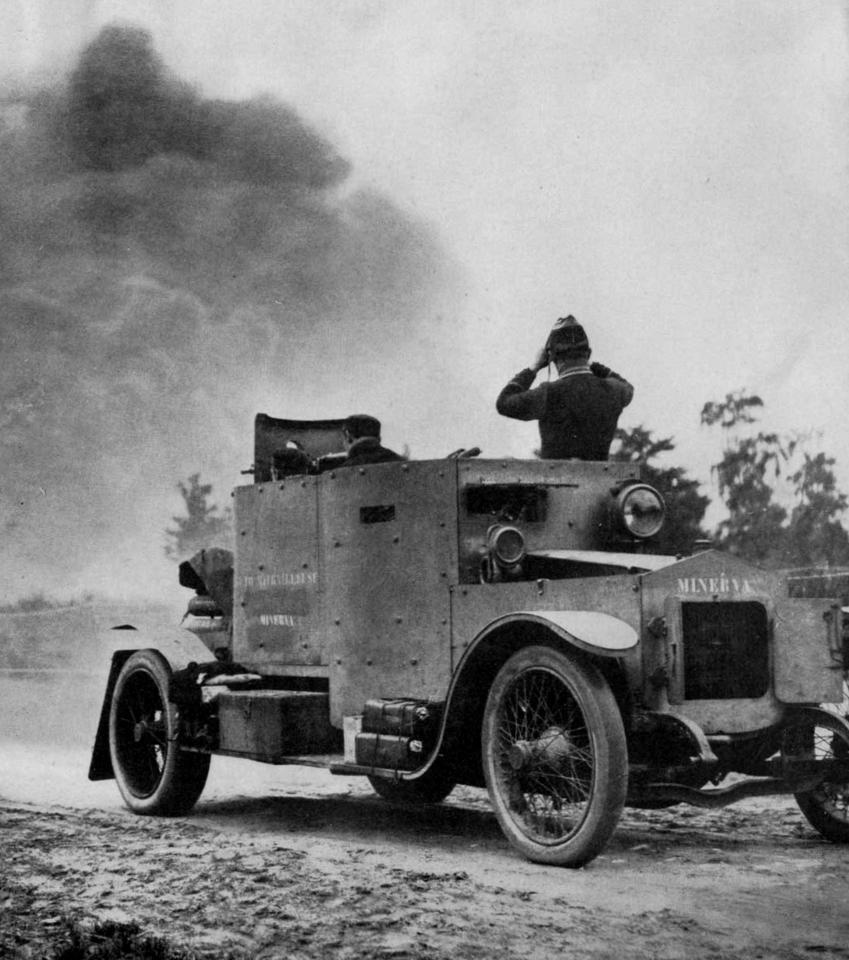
left=0, top=0, right=849, bottom=596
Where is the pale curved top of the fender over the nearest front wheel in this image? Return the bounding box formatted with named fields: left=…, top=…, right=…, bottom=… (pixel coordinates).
left=471, top=610, right=639, bottom=657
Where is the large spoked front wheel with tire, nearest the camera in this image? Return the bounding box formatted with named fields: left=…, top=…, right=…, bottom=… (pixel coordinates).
left=482, top=646, right=628, bottom=867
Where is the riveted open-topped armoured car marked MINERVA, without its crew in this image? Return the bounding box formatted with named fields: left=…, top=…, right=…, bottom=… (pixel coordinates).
left=89, top=414, right=849, bottom=867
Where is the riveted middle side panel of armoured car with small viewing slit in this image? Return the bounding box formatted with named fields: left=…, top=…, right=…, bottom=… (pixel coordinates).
left=319, top=460, right=457, bottom=723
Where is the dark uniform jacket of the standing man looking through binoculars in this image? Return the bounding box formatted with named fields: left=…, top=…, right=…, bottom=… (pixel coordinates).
left=496, top=366, right=634, bottom=460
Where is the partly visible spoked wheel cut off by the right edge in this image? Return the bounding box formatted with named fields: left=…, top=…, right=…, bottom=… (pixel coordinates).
left=781, top=710, right=849, bottom=843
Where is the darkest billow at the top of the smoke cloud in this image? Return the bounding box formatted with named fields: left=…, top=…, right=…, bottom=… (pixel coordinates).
left=53, top=27, right=348, bottom=189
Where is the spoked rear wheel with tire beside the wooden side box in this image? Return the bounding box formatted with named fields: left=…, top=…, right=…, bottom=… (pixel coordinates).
left=109, top=650, right=209, bottom=816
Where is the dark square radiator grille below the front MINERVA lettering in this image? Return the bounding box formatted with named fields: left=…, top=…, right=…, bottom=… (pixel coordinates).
left=681, top=600, right=769, bottom=700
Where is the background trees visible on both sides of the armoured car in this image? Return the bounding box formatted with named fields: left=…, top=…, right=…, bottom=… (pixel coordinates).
left=165, top=390, right=849, bottom=569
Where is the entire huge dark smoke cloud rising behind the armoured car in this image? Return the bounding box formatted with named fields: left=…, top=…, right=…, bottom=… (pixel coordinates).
left=0, top=27, right=452, bottom=599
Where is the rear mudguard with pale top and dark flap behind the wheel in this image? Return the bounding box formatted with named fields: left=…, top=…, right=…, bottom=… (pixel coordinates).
left=88, top=624, right=211, bottom=780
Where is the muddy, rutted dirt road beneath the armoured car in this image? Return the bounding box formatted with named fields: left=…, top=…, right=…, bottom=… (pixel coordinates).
left=0, top=740, right=849, bottom=960
